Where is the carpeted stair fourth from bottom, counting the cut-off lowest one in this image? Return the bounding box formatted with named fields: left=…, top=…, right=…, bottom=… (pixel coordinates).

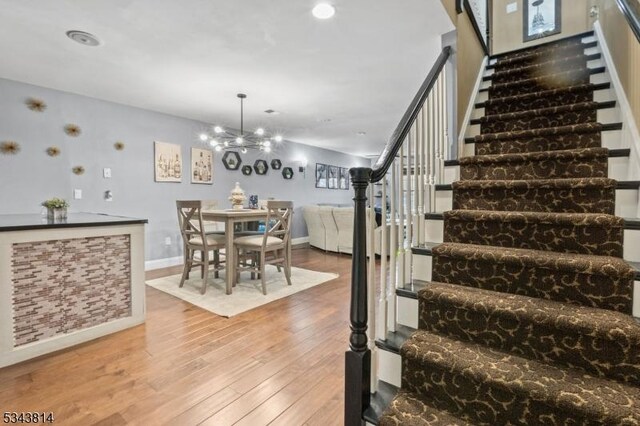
left=431, top=243, right=635, bottom=314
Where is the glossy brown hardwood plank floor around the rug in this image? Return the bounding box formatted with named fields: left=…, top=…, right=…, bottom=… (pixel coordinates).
left=0, top=248, right=351, bottom=426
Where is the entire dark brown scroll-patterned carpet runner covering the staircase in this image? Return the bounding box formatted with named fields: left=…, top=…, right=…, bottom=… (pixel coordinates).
left=380, top=33, right=640, bottom=426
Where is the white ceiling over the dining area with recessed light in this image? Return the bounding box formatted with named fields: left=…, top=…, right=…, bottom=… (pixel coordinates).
left=0, top=0, right=453, bottom=155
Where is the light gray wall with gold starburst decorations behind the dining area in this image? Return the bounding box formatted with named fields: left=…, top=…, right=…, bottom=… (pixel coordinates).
left=0, top=79, right=369, bottom=260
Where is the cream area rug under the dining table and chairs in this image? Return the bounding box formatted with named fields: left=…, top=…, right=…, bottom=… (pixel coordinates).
left=147, top=265, right=338, bottom=317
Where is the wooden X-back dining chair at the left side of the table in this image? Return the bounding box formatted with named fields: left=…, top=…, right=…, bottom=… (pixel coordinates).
left=176, top=201, right=225, bottom=294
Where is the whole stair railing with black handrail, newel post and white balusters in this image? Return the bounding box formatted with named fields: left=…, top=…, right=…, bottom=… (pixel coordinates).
left=344, top=46, right=452, bottom=426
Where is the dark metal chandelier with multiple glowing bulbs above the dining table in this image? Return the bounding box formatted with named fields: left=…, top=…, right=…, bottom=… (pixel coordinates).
left=200, top=93, right=282, bottom=154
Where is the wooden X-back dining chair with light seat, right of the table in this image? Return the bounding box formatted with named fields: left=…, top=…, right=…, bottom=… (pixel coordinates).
left=234, top=201, right=293, bottom=295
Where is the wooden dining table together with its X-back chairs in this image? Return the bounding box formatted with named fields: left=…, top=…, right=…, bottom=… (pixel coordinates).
left=176, top=200, right=293, bottom=295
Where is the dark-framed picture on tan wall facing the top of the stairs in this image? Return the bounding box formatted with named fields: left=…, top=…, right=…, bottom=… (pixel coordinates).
left=522, top=0, right=562, bottom=42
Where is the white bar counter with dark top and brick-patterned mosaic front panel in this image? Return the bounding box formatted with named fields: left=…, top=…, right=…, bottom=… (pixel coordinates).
left=0, top=213, right=147, bottom=367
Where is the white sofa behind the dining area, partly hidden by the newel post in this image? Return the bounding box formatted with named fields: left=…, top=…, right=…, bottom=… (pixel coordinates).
left=302, top=205, right=390, bottom=256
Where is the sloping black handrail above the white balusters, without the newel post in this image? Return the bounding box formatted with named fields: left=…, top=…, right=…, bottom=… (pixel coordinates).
left=368, top=46, right=451, bottom=183
